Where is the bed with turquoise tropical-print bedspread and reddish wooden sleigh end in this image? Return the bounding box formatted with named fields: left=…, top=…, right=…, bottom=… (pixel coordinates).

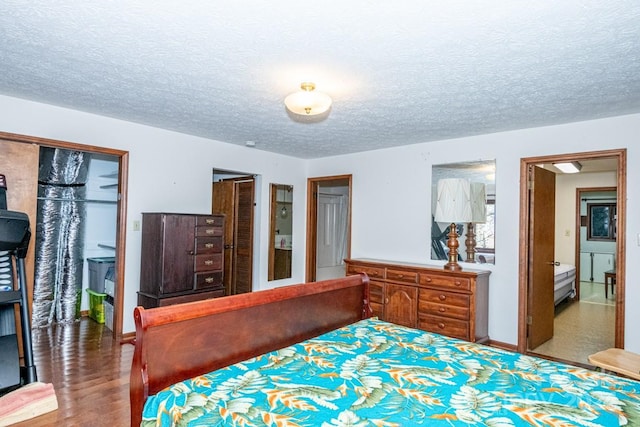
left=131, top=275, right=640, bottom=427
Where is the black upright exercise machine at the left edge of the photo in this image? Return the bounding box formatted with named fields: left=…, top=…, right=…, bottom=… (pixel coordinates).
left=0, top=174, right=37, bottom=395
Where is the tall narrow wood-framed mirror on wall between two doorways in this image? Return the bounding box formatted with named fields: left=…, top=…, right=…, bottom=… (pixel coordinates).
left=269, top=184, right=293, bottom=280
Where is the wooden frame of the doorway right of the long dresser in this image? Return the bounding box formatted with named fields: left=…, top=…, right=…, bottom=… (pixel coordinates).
left=517, top=149, right=627, bottom=354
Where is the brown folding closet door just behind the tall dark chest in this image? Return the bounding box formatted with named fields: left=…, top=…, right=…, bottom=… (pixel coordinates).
left=212, top=177, right=255, bottom=295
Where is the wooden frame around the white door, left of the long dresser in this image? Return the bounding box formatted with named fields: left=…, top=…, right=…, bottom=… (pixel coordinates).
left=305, top=174, right=352, bottom=282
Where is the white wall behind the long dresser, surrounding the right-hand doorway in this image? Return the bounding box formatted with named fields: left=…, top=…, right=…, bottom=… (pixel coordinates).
left=308, top=114, right=640, bottom=352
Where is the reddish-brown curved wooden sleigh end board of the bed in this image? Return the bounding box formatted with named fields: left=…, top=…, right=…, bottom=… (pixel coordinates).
left=130, top=275, right=371, bottom=426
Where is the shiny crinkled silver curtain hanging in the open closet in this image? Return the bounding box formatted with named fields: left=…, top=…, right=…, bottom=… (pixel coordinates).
left=32, top=147, right=90, bottom=327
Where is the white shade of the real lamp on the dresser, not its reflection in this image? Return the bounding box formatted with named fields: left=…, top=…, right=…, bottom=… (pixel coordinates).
left=435, top=178, right=473, bottom=223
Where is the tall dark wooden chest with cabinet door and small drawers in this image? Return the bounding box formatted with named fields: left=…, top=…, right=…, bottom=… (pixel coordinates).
left=138, top=213, right=224, bottom=308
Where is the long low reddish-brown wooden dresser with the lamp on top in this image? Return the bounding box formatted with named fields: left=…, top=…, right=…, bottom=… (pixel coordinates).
left=346, top=259, right=491, bottom=342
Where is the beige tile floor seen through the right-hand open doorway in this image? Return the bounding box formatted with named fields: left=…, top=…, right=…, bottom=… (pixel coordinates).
left=533, top=282, right=615, bottom=364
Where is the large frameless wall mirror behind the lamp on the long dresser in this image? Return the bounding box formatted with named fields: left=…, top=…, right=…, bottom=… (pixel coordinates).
left=431, top=160, right=496, bottom=264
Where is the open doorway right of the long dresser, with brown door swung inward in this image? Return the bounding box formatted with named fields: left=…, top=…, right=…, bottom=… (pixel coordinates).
left=518, top=150, right=626, bottom=365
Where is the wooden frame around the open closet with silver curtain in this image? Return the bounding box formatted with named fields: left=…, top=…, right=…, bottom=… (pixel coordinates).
left=0, top=132, right=129, bottom=343
